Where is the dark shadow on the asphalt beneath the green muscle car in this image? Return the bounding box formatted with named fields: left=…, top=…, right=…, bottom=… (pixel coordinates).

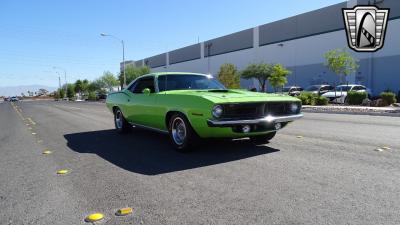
left=64, top=129, right=279, bottom=175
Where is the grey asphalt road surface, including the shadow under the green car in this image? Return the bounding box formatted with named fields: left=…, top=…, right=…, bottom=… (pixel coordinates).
left=0, top=101, right=400, bottom=225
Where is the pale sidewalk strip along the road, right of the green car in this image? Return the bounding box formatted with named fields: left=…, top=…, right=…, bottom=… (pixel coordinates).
left=302, top=105, right=400, bottom=117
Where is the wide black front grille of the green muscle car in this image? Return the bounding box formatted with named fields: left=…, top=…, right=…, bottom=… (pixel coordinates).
left=221, top=102, right=301, bottom=119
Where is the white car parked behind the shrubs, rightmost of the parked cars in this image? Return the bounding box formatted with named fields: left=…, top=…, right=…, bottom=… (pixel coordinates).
left=322, top=84, right=372, bottom=104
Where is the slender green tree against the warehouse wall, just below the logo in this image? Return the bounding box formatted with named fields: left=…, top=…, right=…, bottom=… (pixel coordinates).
left=324, top=49, right=359, bottom=83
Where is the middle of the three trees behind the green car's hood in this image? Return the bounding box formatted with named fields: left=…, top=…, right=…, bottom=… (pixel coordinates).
left=241, top=63, right=272, bottom=91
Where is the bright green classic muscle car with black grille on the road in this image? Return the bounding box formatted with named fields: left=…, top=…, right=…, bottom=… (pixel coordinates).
left=106, top=72, right=303, bottom=151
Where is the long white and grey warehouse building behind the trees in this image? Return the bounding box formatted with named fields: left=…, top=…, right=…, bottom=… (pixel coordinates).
left=125, top=0, right=400, bottom=95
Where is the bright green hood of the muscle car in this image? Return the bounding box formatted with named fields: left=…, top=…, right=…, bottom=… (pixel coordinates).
left=166, top=89, right=300, bottom=103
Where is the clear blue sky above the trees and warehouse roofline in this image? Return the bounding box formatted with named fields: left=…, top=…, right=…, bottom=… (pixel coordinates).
left=0, top=0, right=342, bottom=87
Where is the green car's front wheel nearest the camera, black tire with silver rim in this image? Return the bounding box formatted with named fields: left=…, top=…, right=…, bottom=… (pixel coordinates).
left=168, top=113, right=199, bottom=152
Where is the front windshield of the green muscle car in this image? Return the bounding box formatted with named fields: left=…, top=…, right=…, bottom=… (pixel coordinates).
left=158, top=74, right=226, bottom=91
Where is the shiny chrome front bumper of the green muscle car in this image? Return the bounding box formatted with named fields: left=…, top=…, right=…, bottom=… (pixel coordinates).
left=207, top=114, right=303, bottom=127
